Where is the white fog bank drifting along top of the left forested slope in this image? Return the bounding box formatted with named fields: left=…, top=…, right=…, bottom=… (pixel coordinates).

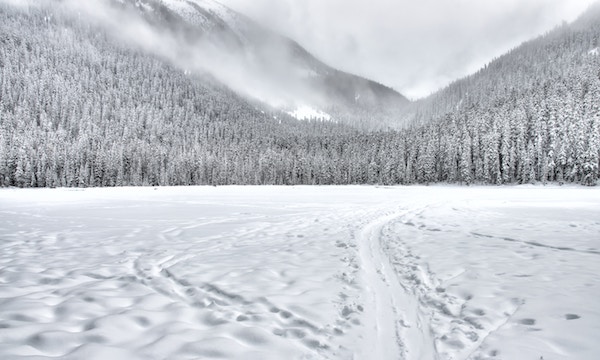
left=54, top=0, right=318, bottom=107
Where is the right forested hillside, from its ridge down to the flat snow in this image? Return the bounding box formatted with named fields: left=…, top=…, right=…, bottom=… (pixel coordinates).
left=394, top=3, right=600, bottom=185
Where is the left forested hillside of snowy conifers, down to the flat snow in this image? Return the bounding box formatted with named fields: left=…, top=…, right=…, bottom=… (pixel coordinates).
left=0, top=4, right=400, bottom=187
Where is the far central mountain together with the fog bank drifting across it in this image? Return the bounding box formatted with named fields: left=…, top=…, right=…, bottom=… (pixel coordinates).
left=56, top=0, right=407, bottom=126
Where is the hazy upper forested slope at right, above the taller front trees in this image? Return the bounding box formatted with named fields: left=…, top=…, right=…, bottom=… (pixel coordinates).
left=404, top=2, right=600, bottom=123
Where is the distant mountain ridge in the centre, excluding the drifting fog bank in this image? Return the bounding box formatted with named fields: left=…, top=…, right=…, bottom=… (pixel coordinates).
left=113, top=0, right=408, bottom=128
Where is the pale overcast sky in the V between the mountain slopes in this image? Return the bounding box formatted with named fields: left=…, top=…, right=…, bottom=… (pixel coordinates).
left=219, top=0, right=594, bottom=99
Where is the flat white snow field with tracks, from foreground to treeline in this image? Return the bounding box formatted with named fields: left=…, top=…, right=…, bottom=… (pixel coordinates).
left=0, top=186, right=600, bottom=360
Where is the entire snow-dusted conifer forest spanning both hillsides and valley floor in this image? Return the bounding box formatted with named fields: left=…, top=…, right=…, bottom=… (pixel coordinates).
left=0, top=1, right=600, bottom=187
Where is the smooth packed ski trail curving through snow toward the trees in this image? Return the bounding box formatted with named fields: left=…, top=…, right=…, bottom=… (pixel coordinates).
left=358, top=209, right=437, bottom=360
